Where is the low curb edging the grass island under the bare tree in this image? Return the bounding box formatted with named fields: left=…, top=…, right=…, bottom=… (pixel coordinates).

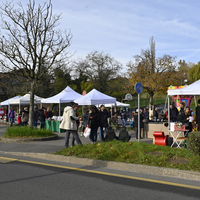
left=0, top=135, right=58, bottom=142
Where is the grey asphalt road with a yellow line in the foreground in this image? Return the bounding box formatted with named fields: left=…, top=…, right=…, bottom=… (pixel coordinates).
left=0, top=155, right=200, bottom=200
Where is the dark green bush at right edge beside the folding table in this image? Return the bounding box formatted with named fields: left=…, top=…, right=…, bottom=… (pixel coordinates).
left=188, top=131, right=200, bottom=155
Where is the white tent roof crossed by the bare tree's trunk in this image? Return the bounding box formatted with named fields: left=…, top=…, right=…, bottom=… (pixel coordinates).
left=9, top=93, right=43, bottom=105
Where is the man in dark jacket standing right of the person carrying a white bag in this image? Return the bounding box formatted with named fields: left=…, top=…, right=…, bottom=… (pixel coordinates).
left=99, top=105, right=110, bottom=141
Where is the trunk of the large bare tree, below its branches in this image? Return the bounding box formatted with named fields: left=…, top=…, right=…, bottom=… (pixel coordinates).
left=29, top=81, right=35, bottom=127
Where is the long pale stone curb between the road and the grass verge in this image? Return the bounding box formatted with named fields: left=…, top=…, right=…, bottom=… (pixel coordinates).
left=0, top=151, right=200, bottom=181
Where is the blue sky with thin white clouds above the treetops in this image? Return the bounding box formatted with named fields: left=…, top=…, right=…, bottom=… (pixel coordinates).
left=14, top=0, right=200, bottom=69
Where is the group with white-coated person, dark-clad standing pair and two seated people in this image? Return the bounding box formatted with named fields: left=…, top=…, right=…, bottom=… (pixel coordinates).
left=60, top=102, right=130, bottom=148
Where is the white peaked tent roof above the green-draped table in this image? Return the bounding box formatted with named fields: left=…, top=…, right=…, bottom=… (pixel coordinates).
left=41, top=86, right=82, bottom=103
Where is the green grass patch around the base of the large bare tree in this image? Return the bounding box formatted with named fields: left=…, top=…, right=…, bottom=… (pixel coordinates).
left=3, top=126, right=55, bottom=138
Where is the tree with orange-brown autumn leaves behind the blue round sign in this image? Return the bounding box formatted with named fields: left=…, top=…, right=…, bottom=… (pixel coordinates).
left=127, top=37, right=180, bottom=105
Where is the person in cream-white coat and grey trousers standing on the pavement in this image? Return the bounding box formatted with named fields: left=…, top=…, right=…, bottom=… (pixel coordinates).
left=59, top=102, right=82, bottom=148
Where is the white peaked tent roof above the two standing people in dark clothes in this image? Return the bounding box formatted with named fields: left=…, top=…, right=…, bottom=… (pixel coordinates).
left=75, top=89, right=116, bottom=105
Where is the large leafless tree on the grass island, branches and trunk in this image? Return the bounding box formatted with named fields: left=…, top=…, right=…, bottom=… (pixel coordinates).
left=0, top=0, right=72, bottom=126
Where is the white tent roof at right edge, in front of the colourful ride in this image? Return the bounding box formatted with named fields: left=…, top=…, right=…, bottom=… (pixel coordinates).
left=167, top=80, right=200, bottom=96
